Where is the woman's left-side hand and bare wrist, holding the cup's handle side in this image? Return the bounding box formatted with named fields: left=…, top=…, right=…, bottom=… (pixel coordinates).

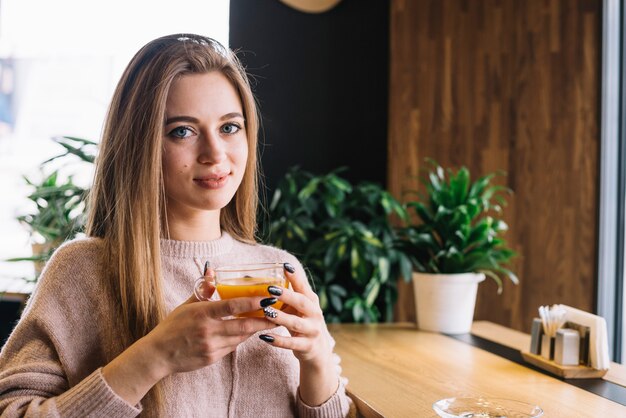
left=102, top=268, right=273, bottom=405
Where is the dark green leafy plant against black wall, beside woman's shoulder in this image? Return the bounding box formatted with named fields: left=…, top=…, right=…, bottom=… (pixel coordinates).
left=260, top=168, right=412, bottom=322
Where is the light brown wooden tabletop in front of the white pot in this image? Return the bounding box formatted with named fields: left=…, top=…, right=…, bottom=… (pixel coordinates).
left=329, top=323, right=626, bottom=418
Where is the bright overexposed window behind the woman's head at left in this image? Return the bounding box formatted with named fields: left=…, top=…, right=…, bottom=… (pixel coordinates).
left=0, top=0, right=229, bottom=292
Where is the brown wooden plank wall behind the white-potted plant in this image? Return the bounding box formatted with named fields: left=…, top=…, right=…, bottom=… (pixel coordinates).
left=388, top=0, right=602, bottom=331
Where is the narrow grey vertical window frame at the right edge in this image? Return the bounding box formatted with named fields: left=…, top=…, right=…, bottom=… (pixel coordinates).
left=597, top=0, right=626, bottom=362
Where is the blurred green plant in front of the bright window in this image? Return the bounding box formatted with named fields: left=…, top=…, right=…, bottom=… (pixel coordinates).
left=7, top=136, right=96, bottom=280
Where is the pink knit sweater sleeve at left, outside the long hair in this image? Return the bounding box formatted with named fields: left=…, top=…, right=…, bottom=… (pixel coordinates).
left=0, top=240, right=141, bottom=417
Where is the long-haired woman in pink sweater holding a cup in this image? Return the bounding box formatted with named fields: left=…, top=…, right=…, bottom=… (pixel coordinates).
left=0, top=35, right=349, bottom=417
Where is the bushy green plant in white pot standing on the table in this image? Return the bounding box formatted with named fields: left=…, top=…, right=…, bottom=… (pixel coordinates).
left=400, top=160, right=518, bottom=334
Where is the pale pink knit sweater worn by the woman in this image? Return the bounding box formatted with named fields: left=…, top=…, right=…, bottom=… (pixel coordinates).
left=0, top=233, right=349, bottom=418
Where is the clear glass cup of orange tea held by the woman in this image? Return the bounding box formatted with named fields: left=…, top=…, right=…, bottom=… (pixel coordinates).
left=194, top=263, right=287, bottom=318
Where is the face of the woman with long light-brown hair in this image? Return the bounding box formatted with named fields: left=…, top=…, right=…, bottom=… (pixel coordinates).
left=163, top=71, right=248, bottom=216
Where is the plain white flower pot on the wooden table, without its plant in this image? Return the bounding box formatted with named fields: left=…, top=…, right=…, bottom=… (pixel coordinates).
left=413, top=272, right=485, bottom=334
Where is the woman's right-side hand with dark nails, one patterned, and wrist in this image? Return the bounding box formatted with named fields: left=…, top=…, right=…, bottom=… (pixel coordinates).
left=259, top=263, right=339, bottom=406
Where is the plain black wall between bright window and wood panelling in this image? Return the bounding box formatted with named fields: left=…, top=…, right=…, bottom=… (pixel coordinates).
left=230, top=0, right=389, bottom=193
